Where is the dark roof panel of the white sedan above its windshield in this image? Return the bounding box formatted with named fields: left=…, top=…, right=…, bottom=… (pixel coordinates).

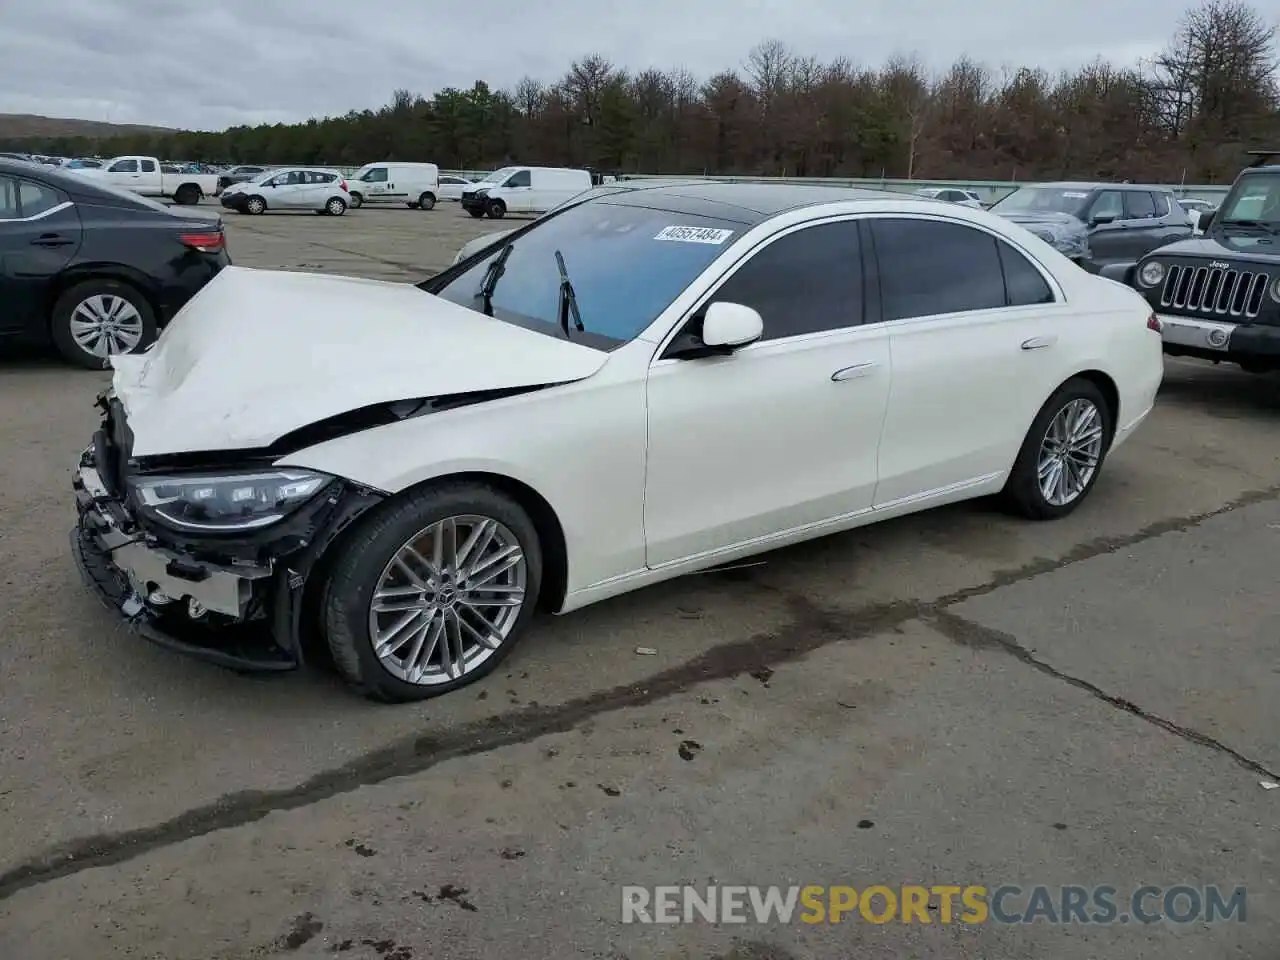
left=595, top=180, right=911, bottom=225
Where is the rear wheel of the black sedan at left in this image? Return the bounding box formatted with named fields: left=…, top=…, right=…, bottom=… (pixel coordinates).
left=50, top=279, right=156, bottom=370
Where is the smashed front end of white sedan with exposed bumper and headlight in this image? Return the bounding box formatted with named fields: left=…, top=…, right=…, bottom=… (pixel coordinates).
left=72, top=392, right=384, bottom=671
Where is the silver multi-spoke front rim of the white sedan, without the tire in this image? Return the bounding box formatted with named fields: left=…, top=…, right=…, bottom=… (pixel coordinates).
left=369, top=515, right=529, bottom=686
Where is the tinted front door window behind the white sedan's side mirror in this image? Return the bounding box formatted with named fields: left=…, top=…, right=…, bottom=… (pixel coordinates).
left=712, top=220, right=863, bottom=340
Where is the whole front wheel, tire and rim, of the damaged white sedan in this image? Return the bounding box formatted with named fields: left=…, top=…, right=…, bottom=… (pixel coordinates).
left=321, top=483, right=543, bottom=703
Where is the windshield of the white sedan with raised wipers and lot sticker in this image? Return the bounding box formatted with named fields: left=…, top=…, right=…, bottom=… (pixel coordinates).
left=432, top=198, right=744, bottom=348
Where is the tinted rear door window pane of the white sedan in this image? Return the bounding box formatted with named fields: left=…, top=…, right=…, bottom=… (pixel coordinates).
left=869, top=219, right=1005, bottom=320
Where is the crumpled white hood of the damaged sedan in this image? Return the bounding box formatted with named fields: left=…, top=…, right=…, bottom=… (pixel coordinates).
left=111, top=266, right=608, bottom=457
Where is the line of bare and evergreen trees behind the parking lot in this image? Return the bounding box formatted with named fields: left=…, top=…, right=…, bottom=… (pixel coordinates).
left=8, top=0, right=1280, bottom=183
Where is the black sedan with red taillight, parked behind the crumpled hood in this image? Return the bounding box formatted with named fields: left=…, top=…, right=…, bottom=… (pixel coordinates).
left=0, top=160, right=230, bottom=370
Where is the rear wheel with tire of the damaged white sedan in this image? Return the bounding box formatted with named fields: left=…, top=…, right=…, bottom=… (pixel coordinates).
left=1004, top=376, right=1115, bottom=520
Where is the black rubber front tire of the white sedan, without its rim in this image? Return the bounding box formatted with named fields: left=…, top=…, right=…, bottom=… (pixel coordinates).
left=320, top=481, right=543, bottom=703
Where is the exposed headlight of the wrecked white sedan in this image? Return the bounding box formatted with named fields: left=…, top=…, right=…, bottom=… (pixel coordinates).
left=132, top=470, right=333, bottom=534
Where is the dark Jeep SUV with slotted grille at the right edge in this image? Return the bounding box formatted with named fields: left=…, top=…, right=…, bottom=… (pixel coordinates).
left=1129, top=151, right=1280, bottom=372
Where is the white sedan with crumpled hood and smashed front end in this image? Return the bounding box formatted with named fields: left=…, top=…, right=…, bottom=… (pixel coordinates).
left=72, top=183, right=1164, bottom=700
